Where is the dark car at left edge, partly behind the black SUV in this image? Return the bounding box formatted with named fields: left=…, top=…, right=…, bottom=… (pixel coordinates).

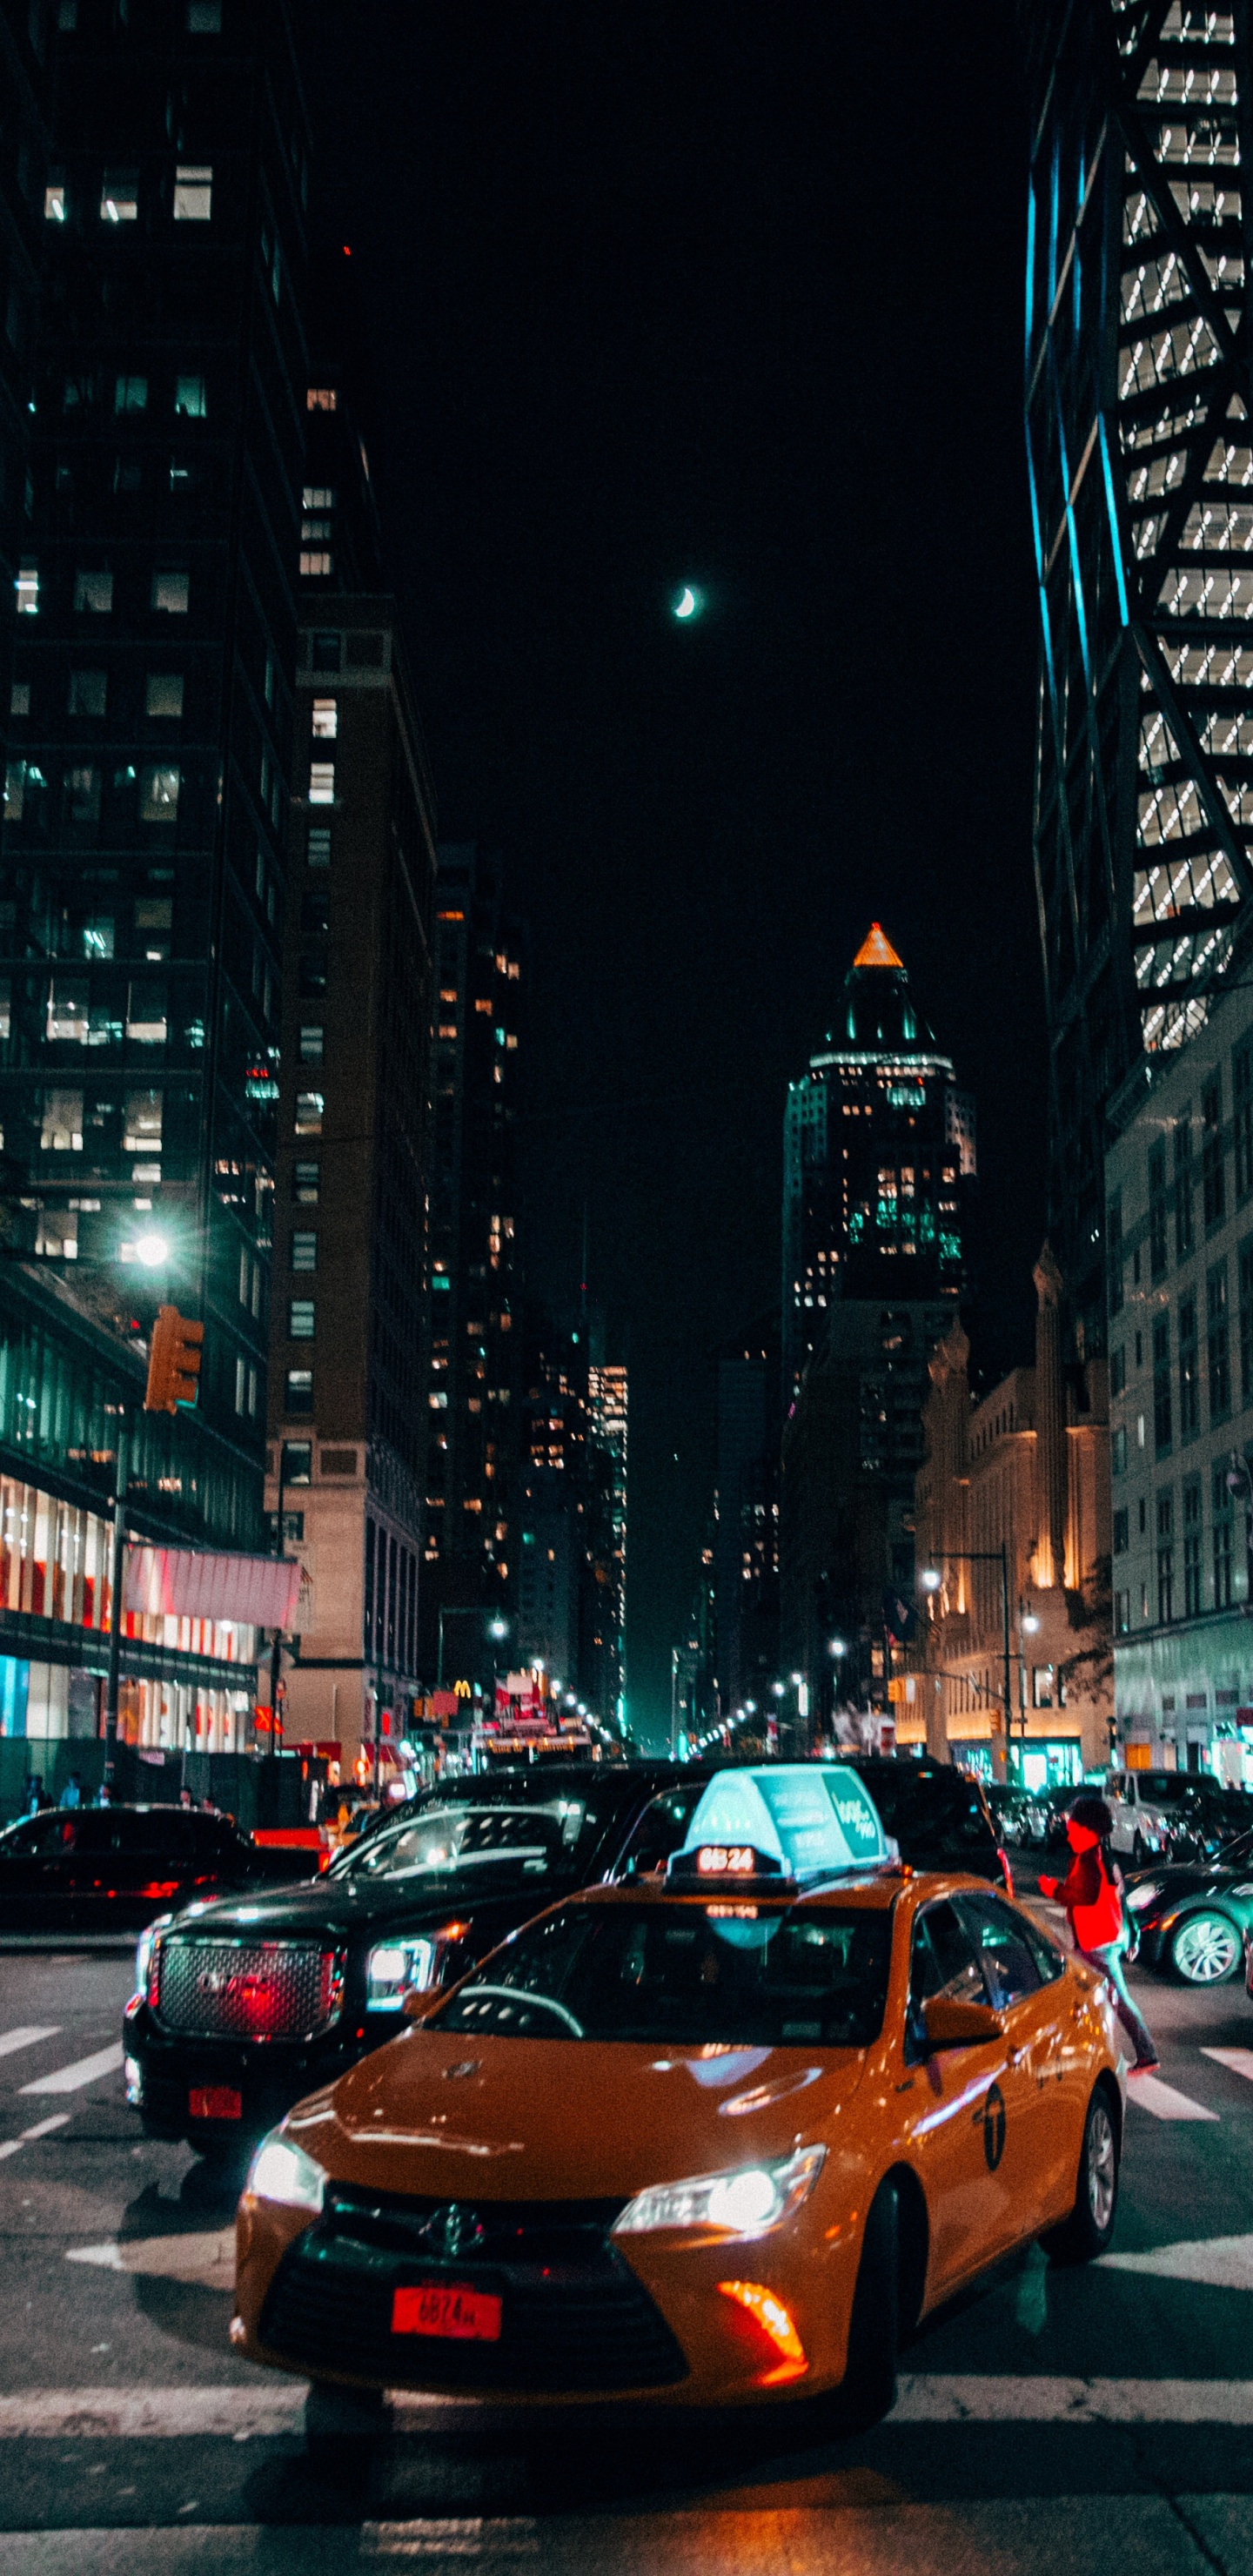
left=0, top=1806, right=317, bottom=1932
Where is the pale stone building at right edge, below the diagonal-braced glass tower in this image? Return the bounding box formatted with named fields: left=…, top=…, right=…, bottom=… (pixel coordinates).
left=1106, top=989, right=1253, bottom=1780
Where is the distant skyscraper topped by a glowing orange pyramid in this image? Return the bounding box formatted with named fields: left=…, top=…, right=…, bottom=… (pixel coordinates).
left=784, top=922, right=975, bottom=1409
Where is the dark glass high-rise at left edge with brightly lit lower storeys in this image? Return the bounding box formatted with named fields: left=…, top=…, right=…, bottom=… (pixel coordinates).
left=0, top=0, right=310, bottom=1752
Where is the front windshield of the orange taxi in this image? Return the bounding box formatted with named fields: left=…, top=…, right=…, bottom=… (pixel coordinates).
left=425, top=1901, right=892, bottom=2048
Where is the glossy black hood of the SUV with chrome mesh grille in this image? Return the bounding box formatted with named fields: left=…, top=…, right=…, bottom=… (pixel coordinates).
left=155, top=1860, right=578, bottom=1940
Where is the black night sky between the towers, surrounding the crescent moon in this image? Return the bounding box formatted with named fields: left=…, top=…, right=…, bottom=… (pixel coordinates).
left=310, top=0, right=1044, bottom=1731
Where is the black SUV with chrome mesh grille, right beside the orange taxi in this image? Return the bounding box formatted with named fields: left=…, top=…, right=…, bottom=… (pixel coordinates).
left=124, top=1762, right=704, bottom=2157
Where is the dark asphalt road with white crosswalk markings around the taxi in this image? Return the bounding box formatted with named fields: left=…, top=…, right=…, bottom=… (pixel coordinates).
left=0, top=1885, right=1253, bottom=2576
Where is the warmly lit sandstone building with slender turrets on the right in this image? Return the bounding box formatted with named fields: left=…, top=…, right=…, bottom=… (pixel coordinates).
left=917, top=1244, right=1114, bottom=1793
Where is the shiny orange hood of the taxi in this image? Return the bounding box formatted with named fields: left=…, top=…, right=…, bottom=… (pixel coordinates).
left=284, top=2025, right=867, bottom=2200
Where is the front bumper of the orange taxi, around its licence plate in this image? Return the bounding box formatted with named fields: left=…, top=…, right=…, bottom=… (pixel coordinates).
left=232, top=2190, right=859, bottom=2406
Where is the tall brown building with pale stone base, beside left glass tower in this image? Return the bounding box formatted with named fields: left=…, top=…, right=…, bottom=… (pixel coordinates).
left=265, top=592, right=436, bottom=1768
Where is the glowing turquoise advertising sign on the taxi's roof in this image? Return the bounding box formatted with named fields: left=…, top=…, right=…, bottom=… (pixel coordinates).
left=667, top=1762, right=892, bottom=1886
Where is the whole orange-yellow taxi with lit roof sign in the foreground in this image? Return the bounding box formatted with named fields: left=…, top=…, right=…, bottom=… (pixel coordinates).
left=232, top=1765, right=1124, bottom=2421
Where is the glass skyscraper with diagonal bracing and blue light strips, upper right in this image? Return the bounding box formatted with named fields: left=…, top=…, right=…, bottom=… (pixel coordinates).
left=1023, top=0, right=1253, bottom=1347
